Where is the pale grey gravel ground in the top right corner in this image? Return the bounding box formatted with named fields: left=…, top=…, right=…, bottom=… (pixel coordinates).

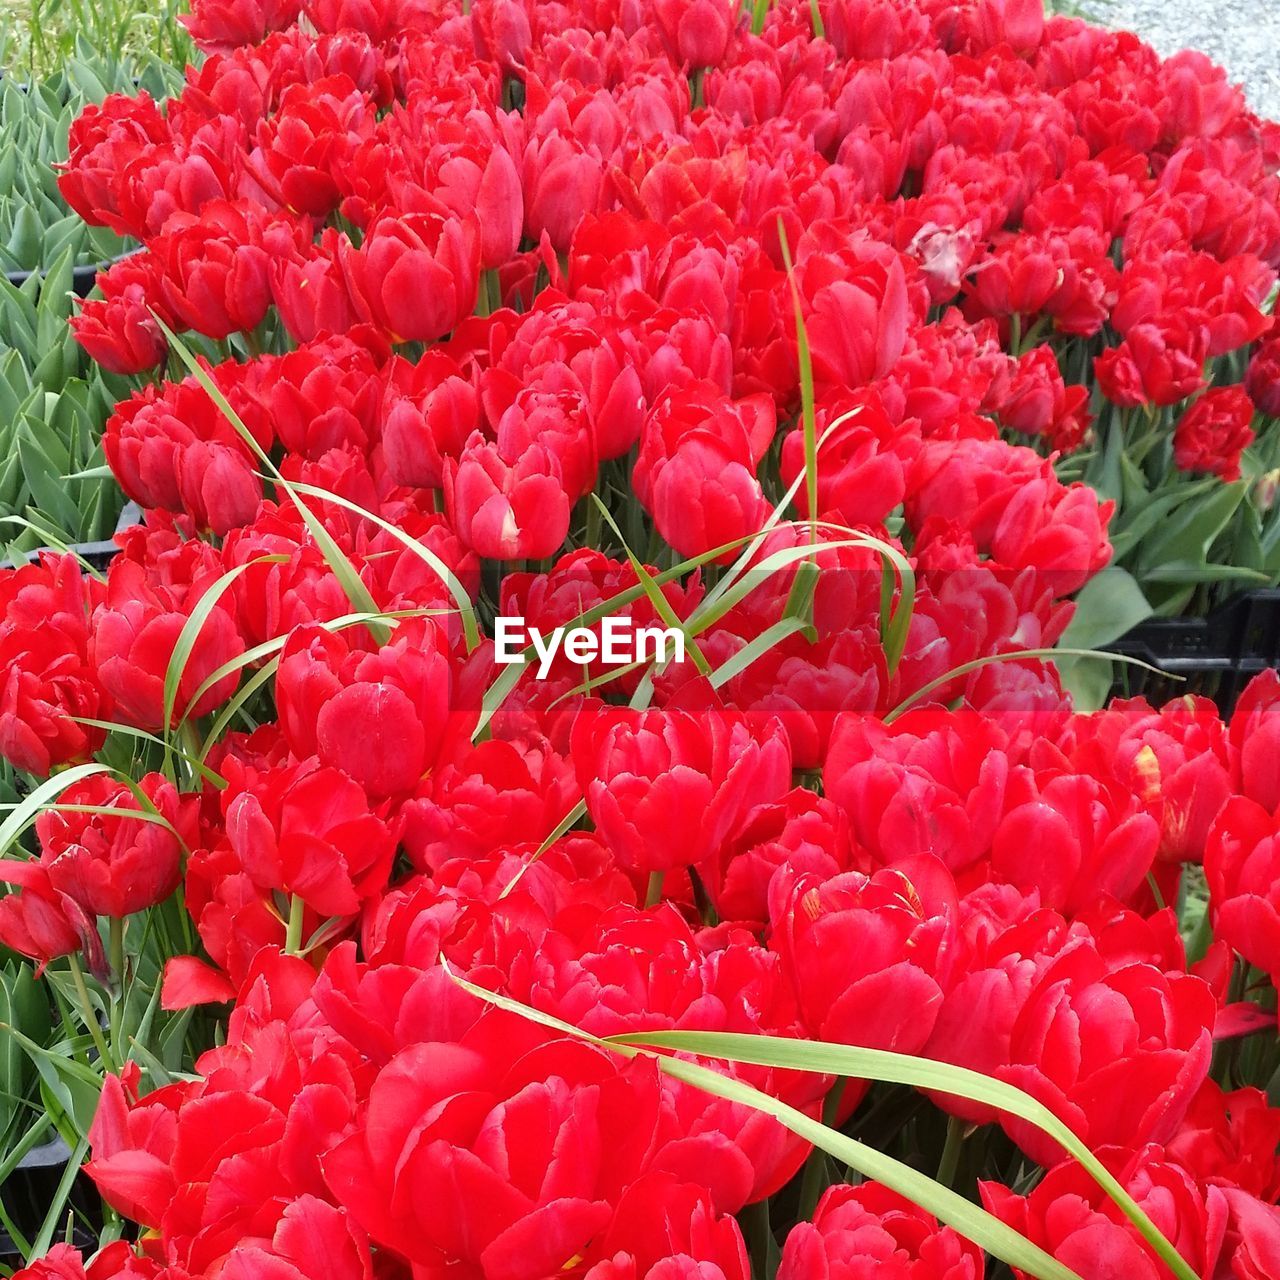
left=1084, top=0, right=1280, bottom=120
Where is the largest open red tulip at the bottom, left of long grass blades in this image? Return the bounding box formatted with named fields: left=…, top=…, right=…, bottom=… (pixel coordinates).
left=324, top=1034, right=662, bottom=1280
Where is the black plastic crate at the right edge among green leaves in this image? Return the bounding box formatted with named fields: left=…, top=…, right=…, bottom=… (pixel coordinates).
left=1107, top=589, right=1280, bottom=716
